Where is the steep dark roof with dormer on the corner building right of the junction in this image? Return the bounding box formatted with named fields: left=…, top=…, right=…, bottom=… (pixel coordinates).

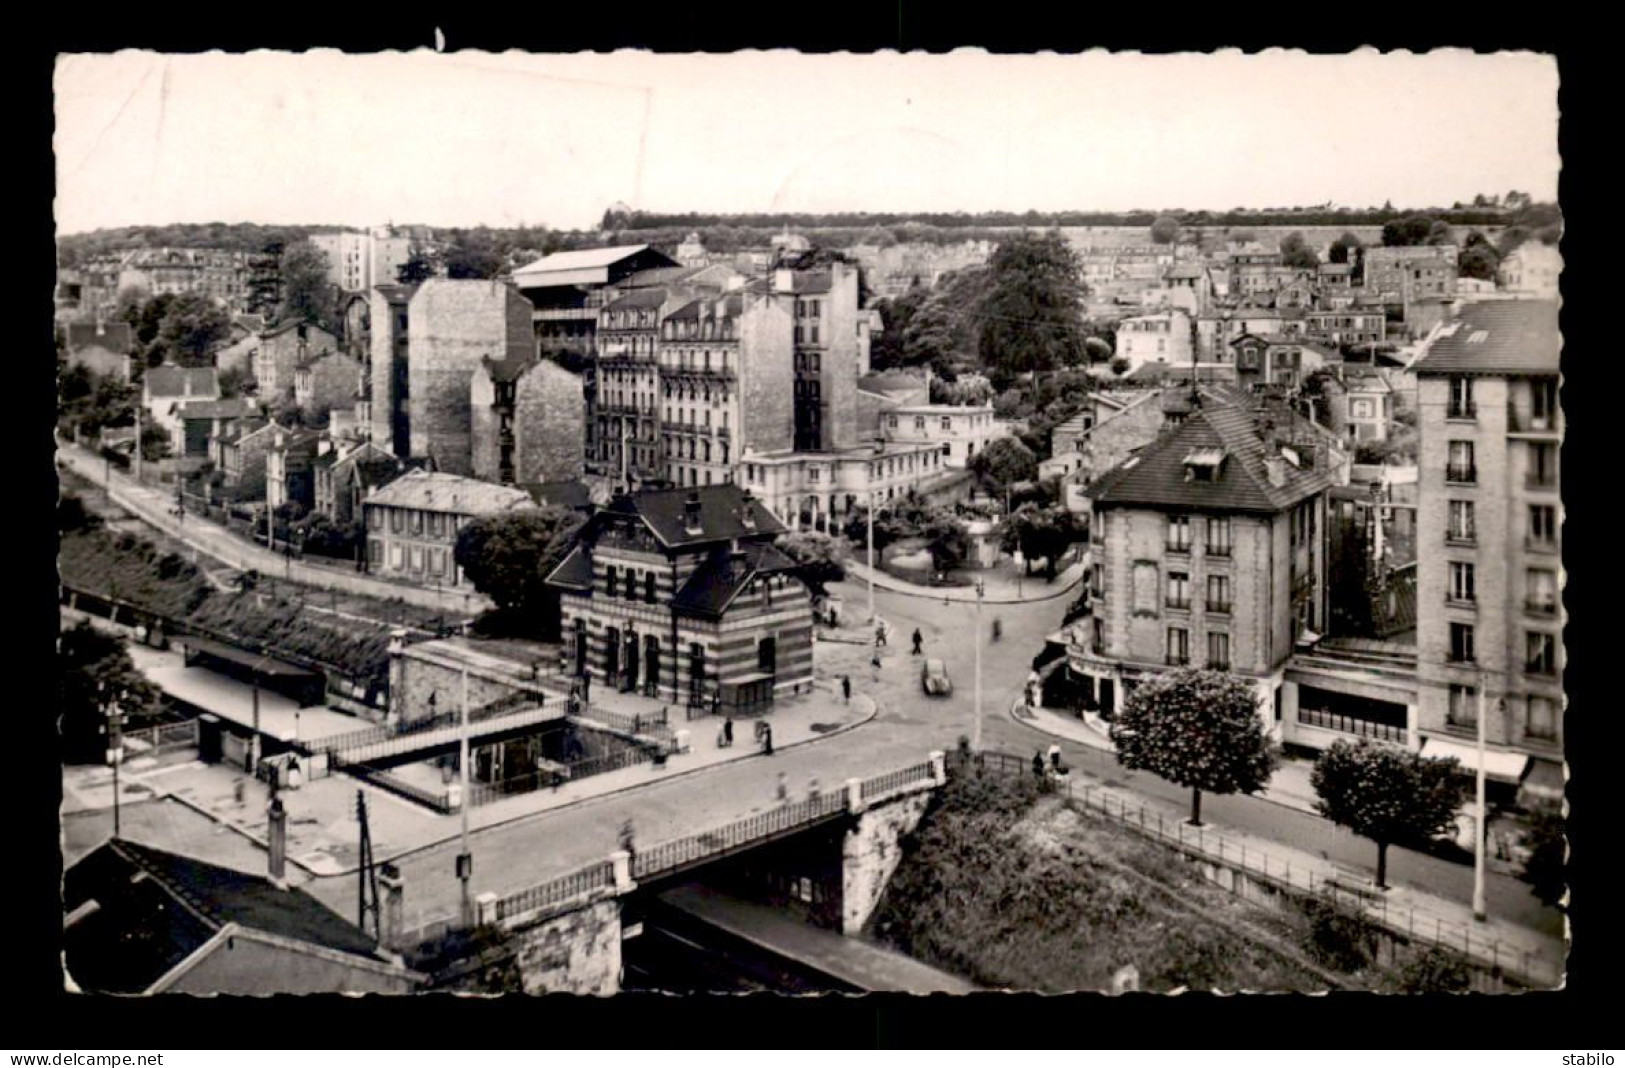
left=1087, top=405, right=1334, bottom=514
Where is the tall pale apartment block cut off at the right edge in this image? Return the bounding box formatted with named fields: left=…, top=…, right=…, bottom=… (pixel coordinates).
left=1412, top=301, right=1565, bottom=792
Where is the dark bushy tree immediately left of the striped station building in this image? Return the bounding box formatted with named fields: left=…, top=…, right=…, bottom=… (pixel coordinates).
left=452, top=506, right=582, bottom=629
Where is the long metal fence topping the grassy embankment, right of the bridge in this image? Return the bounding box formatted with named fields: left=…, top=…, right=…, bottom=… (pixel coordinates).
left=957, top=753, right=1563, bottom=987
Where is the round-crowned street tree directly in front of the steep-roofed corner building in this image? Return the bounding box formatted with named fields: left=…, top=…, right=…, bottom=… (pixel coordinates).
left=1110, top=668, right=1276, bottom=826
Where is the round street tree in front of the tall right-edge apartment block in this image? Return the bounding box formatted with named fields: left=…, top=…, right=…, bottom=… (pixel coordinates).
left=1310, top=738, right=1466, bottom=889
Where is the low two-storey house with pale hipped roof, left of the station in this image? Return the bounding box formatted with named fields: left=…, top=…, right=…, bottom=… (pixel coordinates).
left=364, top=470, right=536, bottom=585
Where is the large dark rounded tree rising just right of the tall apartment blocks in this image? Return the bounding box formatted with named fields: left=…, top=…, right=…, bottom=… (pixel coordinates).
left=977, top=231, right=1089, bottom=385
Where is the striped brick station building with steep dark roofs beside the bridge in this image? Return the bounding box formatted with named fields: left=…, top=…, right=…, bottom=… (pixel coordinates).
left=548, top=486, right=813, bottom=715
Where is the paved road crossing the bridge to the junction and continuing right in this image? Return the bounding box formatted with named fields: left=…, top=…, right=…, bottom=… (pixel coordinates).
left=292, top=584, right=1563, bottom=936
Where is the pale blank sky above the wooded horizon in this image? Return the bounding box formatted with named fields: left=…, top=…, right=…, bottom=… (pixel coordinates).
left=54, top=50, right=1560, bottom=234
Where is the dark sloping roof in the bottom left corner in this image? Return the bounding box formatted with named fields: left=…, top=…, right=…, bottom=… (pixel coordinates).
left=63, top=839, right=379, bottom=993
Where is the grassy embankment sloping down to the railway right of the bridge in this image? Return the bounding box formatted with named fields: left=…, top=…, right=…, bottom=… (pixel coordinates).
left=871, top=775, right=1466, bottom=993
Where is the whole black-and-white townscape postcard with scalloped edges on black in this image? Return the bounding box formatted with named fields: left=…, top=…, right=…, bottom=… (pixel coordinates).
left=47, top=41, right=1573, bottom=1027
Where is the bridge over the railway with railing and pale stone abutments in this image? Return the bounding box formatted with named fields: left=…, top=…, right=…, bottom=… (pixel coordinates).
left=380, top=751, right=946, bottom=995
